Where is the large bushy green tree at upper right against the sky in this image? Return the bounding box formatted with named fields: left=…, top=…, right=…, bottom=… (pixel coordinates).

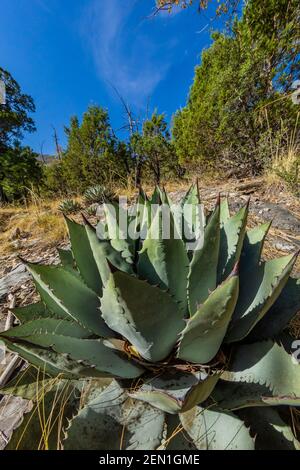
left=173, top=0, right=300, bottom=174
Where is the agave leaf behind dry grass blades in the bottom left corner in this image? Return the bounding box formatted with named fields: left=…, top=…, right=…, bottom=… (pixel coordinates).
left=6, top=384, right=77, bottom=450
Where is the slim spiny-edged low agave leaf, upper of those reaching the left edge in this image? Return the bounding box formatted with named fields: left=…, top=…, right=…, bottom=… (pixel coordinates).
left=2, top=337, right=101, bottom=379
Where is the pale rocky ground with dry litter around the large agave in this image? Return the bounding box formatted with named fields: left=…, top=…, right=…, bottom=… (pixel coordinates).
left=0, top=178, right=300, bottom=449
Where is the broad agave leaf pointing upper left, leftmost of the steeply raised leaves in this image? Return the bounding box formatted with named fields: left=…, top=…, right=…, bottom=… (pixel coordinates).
left=28, top=264, right=110, bottom=337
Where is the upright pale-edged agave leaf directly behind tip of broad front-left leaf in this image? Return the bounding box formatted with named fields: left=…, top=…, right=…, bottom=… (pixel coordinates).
left=85, top=220, right=133, bottom=285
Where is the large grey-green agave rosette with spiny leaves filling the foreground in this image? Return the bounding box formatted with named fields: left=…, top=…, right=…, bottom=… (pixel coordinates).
left=1, top=186, right=300, bottom=450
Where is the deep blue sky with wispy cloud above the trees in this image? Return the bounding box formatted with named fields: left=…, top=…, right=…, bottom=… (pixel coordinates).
left=0, top=0, right=222, bottom=153
